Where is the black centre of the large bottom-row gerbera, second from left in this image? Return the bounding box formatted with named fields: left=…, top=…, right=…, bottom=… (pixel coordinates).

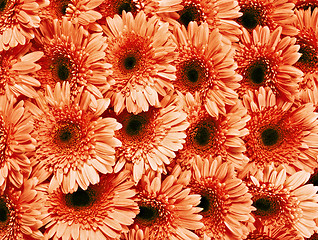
left=66, top=188, right=94, bottom=207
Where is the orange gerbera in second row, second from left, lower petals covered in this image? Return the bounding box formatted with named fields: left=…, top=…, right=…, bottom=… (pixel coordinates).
left=34, top=18, right=111, bottom=98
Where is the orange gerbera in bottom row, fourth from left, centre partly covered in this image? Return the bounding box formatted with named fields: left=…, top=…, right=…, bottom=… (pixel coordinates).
left=188, top=157, right=254, bottom=240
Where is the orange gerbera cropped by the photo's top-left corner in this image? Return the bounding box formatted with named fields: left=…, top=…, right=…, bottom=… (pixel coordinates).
left=0, top=0, right=48, bottom=51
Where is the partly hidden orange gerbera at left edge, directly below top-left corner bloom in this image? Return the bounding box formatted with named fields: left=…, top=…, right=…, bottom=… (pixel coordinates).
left=0, top=44, right=43, bottom=98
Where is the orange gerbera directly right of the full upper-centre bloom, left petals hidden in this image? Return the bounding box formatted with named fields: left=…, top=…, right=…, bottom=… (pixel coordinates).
left=173, top=22, right=242, bottom=114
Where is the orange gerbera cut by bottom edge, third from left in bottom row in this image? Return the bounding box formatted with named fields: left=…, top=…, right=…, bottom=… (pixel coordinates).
left=126, top=171, right=203, bottom=240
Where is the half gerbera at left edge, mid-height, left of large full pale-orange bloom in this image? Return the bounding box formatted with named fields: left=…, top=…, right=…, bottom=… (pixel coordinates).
left=0, top=96, right=36, bottom=190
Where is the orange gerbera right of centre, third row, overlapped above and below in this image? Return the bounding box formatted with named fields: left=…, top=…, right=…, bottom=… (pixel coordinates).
left=174, top=92, right=250, bottom=172
